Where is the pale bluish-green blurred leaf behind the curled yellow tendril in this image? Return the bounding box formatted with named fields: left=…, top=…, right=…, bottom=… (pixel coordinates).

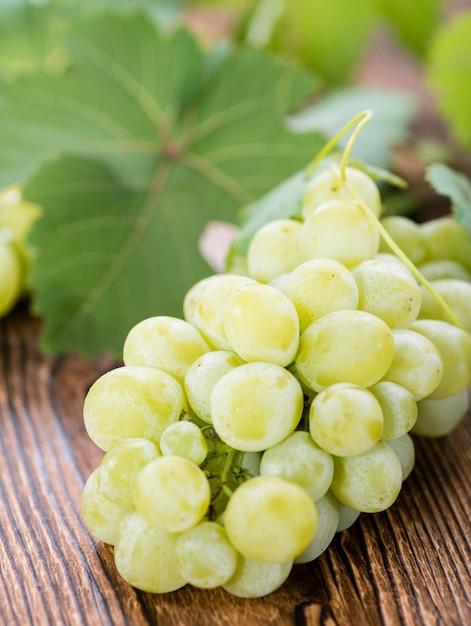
left=289, top=87, right=418, bottom=168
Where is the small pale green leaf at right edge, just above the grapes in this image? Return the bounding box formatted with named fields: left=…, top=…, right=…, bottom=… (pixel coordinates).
left=425, top=163, right=471, bottom=241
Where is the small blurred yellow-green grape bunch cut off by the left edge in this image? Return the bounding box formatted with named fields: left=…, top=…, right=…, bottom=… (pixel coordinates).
left=0, top=187, right=39, bottom=316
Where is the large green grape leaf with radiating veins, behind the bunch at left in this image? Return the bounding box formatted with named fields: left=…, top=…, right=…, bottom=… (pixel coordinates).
left=11, top=14, right=325, bottom=355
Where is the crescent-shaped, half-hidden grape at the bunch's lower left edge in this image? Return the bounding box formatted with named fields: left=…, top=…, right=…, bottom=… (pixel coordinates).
left=81, top=468, right=135, bottom=546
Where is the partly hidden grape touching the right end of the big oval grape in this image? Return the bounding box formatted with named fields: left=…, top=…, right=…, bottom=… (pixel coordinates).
left=383, top=326, right=444, bottom=400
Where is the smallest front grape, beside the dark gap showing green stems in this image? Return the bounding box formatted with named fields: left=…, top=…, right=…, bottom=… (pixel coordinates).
left=160, top=421, right=208, bottom=465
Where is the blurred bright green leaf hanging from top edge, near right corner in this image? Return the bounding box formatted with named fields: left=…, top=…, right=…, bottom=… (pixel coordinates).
left=379, top=0, right=444, bottom=55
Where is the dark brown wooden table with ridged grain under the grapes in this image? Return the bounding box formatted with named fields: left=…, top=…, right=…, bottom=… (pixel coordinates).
left=0, top=306, right=471, bottom=626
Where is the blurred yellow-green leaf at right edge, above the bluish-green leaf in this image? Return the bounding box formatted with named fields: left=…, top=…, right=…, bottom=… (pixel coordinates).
left=427, top=11, right=471, bottom=148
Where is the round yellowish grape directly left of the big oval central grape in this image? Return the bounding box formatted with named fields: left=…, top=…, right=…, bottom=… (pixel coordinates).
left=224, top=283, right=299, bottom=366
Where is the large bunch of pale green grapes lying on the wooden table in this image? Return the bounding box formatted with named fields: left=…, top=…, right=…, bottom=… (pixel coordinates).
left=82, top=167, right=471, bottom=597
